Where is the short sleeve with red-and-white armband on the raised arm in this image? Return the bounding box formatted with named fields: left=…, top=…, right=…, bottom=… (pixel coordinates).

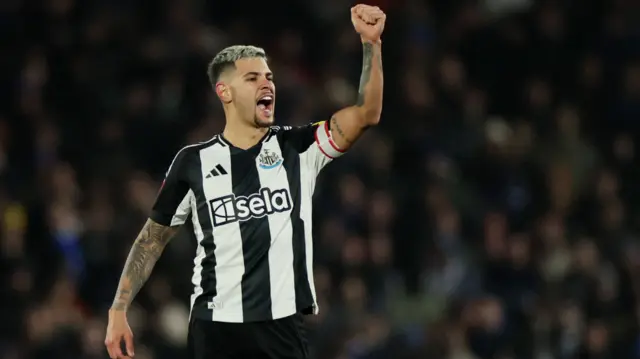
left=286, top=121, right=345, bottom=175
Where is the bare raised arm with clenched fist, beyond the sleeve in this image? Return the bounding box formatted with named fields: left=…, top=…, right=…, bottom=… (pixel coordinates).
left=329, top=5, right=386, bottom=151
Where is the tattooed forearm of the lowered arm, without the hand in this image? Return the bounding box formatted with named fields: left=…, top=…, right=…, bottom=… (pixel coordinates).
left=111, top=220, right=177, bottom=310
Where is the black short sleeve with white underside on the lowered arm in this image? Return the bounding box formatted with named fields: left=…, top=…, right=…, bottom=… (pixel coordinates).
left=150, top=150, right=193, bottom=227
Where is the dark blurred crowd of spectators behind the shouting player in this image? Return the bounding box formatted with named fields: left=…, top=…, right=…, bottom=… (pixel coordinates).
left=0, top=0, right=640, bottom=359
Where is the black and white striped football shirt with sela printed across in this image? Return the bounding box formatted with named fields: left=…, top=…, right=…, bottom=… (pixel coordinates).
left=151, top=122, right=342, bottom=323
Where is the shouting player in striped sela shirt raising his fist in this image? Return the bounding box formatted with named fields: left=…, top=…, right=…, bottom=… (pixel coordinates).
left=105, top=5, right=386, bottom=359
